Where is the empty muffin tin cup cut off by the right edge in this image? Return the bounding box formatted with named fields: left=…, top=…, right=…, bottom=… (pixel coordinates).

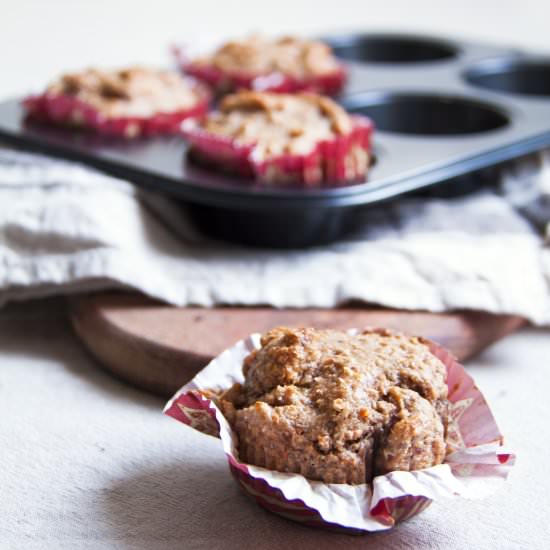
left=464, top=58, right=550, bottom=97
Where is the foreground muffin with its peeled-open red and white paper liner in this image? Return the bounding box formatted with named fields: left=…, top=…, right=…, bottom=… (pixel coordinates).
left=164, top=328, right=515, bottom=534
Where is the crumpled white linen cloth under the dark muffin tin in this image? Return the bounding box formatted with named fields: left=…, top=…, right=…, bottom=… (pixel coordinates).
left=0, top=150, right=550, bottom=324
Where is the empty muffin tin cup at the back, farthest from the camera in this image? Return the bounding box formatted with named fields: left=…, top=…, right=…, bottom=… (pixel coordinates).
left=325, top=34, right=458, bottom=63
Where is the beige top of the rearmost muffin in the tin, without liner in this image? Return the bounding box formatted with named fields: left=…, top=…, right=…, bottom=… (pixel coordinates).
left=193, top=35, right=339, bottom=79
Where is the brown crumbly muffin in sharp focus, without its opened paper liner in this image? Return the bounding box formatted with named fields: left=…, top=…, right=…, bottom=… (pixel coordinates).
left=217, top=327, right=449, bottom=484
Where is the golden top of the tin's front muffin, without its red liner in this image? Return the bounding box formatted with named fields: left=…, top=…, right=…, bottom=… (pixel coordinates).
left=198, top=91, right=353, bottom=160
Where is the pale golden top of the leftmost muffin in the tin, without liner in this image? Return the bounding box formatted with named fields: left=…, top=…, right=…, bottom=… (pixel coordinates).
left=47, top=67, right=203, bottom=118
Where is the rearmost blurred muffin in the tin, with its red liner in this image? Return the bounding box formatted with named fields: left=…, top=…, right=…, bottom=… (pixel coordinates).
left=179, top=36, right=346, bottom=95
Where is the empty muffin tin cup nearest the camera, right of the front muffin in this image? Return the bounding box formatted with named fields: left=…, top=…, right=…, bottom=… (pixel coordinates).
left=342, top=92, right=509, bottom=136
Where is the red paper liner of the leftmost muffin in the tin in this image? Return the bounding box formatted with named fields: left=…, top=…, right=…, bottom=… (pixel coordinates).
left=23, top=84, right=211, bottom=138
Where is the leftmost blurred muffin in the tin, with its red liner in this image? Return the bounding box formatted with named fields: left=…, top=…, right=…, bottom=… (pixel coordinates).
left=24, top=67, right=210, bottom=138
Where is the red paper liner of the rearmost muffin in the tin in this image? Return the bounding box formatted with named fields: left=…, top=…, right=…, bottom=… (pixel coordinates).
left=172, top=47, right=347, bottom=96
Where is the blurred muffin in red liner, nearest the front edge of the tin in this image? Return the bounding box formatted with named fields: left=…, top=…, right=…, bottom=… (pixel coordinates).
left=182, top=91, right=373, bottom=186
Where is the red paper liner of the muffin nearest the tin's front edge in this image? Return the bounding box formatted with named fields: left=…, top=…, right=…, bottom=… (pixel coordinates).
left=182, top=116, right=373, bottom=187
